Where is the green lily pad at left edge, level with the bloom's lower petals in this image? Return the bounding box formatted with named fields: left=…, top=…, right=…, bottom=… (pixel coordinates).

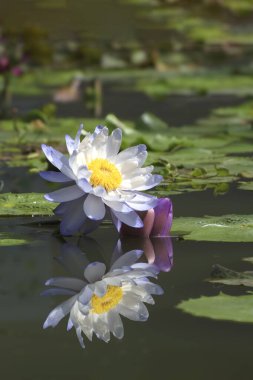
left=0, top=193, right=56, bottom=216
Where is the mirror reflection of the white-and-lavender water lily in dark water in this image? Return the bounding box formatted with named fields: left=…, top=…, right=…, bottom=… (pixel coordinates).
left=43, top=250, right=163, bottom=348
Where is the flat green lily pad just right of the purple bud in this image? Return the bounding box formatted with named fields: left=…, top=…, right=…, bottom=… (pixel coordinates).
left=172, top=215, right=253, bottom=242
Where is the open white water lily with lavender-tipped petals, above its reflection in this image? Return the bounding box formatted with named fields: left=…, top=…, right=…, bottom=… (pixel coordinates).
left=40, top=126, right=162, bottom=235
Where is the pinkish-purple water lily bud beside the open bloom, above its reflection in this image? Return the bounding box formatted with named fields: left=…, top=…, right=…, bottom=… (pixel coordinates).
left=117, top=198, right=173, bottom=237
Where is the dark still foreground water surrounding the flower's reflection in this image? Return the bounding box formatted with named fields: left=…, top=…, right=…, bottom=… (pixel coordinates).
left=0, top=218, right=253, bottom=380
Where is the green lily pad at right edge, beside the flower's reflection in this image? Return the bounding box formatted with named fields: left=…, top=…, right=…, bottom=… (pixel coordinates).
left=177, top=293, right=253, bottom=323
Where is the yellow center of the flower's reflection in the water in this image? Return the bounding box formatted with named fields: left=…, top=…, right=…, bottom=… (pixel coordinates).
left=91, top=285, right=123, bottom=314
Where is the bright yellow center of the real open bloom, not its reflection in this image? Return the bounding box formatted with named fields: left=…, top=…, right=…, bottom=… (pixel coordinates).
left=88, top=158, right=122, bottom=191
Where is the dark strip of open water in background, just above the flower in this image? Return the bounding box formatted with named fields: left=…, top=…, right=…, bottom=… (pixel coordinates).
left=13, top=85, right=246, bottom=126
